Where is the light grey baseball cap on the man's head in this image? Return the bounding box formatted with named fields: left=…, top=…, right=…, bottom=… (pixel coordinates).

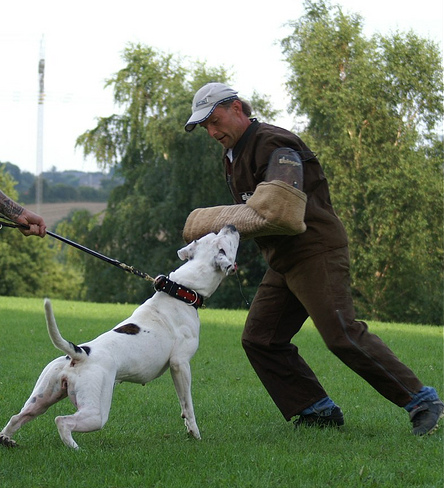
left=185, top=83, right=238, bottom=132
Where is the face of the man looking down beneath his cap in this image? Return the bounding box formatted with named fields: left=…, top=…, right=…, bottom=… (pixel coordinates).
left=199, top=100, right=250, bottom=149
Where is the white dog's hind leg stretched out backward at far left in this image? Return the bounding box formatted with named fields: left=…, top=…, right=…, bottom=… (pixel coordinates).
left=0, top=358, right=67, bottom=447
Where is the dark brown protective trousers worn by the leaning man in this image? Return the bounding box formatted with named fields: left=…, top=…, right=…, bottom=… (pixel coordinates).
left=242, top=248, right=423, bottom=420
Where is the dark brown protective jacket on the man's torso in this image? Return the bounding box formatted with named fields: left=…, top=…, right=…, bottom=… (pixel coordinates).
left=226, top=119, right=347, bottom=273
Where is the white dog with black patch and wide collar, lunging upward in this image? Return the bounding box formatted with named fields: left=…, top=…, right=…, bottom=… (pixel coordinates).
left=0, top=226, right=239, bottom=449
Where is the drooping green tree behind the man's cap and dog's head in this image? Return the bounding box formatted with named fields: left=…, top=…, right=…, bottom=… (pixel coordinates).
left=77, top=44, right=273, bottom=306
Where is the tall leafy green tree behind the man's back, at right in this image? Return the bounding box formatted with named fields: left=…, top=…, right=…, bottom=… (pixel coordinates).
left=282, top=1, right=443, bottom=323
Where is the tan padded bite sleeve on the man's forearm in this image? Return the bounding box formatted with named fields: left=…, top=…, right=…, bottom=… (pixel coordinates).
left=183, top=180, right=307, bottom=242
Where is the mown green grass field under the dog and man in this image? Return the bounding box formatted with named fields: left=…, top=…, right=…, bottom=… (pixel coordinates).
left=0, top=297, right=444, bottom=488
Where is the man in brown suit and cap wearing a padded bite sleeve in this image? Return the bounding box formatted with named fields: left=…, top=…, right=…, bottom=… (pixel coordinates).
left=184, top=83, right=444, bottom=435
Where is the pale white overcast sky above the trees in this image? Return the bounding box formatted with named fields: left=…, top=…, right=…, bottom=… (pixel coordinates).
left=0, top=0, right=443, bottom=174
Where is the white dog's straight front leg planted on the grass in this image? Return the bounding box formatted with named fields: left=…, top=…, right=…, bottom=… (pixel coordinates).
left=170, top=359, right=200, bottom=439
